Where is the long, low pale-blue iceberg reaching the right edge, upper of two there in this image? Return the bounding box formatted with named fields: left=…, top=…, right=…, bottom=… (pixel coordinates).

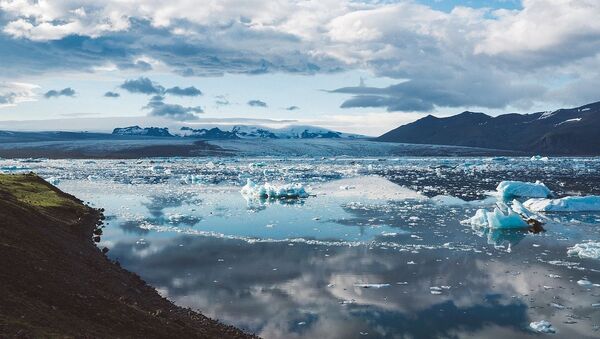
left=523, top=195, right=600, bottom=212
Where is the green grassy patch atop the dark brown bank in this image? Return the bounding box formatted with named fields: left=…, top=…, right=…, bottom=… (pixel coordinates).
left=0, top=173, right=85, bottom=211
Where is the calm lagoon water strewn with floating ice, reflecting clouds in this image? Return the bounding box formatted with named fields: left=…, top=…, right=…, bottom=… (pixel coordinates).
left=0, top=157, right=600, bottom=338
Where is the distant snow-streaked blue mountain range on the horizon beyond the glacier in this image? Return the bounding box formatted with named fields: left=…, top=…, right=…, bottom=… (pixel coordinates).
left=112, top=125, right=365, bottom=140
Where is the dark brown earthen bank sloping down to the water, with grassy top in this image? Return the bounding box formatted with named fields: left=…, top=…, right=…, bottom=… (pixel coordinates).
left=0, top=173, right=255, bottom=338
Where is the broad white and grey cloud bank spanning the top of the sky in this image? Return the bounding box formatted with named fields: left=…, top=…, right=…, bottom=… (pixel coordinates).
left=0, top=0, right=600, bottom=110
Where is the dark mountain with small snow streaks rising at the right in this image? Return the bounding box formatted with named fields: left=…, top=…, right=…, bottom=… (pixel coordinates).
left=375, top=102, right=600, bottom=155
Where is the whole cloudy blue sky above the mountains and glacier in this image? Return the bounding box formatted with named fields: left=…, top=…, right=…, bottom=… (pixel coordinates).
left=0, top=0, right=600, bottom=135
